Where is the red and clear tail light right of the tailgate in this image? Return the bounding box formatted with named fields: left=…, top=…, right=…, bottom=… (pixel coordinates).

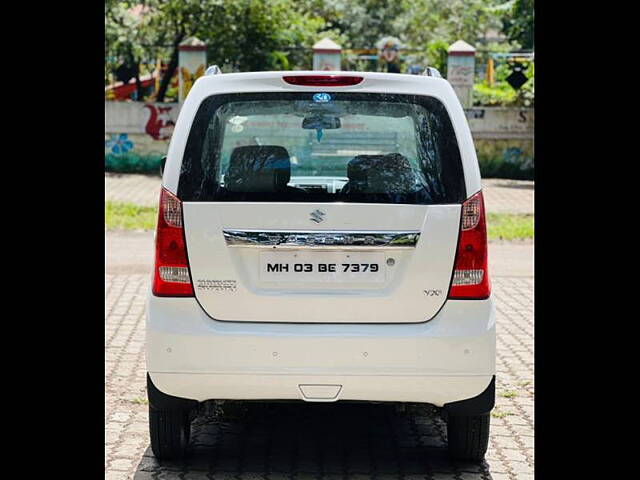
left=449, top=192, right=491, bottom=299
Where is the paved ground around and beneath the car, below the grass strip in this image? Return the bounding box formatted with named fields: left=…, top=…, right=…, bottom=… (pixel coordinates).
left=105, top=232, right=534, bottom=480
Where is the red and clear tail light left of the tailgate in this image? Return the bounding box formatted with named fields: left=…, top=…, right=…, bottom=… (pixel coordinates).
left=152, top=188, right=193, bottom=297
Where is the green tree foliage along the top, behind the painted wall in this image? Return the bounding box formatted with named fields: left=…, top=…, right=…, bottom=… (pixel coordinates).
left=105, top=0, right=533, bottom=104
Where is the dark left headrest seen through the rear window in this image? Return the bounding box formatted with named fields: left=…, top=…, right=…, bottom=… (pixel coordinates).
left=224, top=145, right=291, bottom=192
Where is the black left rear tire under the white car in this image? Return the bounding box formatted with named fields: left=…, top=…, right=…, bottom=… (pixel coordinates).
left=149, top=405, right=191, bottom=460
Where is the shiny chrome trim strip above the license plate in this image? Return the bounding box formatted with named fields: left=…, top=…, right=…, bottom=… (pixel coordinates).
left=222, top=230, right=420, bottom=249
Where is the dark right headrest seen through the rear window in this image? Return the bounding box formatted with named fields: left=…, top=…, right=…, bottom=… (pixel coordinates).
left=347, top=153, right=416, bottom=193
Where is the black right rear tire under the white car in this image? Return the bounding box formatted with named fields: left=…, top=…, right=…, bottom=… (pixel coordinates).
left=447, top=413, right=490, bottom=461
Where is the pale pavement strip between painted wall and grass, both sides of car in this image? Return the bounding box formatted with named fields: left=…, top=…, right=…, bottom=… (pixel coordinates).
left=105, top=173, right=534, bottom=213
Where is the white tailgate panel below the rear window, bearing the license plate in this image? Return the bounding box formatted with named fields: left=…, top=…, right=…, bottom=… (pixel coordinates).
left=183, top=202, right=460, bottom=323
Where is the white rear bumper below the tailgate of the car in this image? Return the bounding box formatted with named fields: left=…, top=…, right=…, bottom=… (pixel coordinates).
left=146, top=296, right=495, bottom=406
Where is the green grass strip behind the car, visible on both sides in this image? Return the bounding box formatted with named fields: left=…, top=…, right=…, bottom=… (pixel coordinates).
left=105, top=202, right=533, bottom=240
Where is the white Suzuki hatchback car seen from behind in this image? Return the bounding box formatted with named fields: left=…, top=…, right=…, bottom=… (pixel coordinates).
left=146, top=69, right=495, bottom=460
